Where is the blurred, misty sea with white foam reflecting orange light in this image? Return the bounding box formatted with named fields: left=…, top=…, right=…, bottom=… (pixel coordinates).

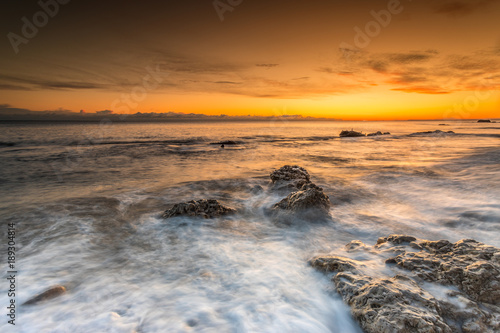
left=0, top=119, right=500, bottom=333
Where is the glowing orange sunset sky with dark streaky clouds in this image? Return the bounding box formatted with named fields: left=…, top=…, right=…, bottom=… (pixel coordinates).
left=0, top=0, right=500, bottom=120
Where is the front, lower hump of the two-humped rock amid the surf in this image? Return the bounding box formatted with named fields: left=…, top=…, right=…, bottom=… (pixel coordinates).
left=273, top=183, right=330, bottom=213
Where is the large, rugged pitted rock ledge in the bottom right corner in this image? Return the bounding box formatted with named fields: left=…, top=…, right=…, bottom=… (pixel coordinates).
left=310, top=235, right=500, bottom=333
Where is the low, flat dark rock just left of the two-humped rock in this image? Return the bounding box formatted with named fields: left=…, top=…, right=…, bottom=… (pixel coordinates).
left=161, top=199, right=236, bottom=219
